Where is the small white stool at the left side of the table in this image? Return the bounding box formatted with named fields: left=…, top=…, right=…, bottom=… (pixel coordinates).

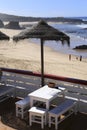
left=15, top=97, right=30, bottom=119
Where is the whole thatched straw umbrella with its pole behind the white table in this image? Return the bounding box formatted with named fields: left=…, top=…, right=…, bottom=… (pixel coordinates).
left=13, top=20, right=70, bottom=86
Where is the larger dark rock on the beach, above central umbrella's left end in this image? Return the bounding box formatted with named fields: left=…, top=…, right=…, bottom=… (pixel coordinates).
left=4, top=21, right=22, bottom=29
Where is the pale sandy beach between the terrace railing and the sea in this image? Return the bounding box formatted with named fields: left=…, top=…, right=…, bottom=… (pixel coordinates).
left=0, top=29, right=87, bottom=80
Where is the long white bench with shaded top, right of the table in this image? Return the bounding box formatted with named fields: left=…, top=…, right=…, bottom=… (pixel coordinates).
left=48, top=100, right=76, bottom=130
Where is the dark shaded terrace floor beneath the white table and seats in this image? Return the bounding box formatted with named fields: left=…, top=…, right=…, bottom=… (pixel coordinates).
left=0, top=98, right=87, bottom=130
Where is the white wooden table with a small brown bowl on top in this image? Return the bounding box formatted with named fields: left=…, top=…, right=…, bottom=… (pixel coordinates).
left=28, top=85, right=61, bottom=110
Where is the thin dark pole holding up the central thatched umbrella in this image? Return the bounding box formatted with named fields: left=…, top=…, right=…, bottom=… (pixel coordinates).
left=41, top=39, right=44, bottom=86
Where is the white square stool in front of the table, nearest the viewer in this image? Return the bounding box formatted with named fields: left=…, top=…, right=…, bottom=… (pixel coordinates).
left=28, top=107, right=46, bottom=129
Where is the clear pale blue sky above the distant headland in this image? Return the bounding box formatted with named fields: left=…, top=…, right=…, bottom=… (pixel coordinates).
left=0, top=0, right=87, bottom=17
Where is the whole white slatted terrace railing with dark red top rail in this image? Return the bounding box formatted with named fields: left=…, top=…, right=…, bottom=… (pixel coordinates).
left=1, top=68, right=87, bottom=113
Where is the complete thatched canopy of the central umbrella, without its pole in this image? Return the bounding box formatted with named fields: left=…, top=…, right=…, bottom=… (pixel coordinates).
left=13, top=20, right=70, bottom=43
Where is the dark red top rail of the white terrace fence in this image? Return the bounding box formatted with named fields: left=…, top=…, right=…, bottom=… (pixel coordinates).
left=1, top=68, right=87, bottom=85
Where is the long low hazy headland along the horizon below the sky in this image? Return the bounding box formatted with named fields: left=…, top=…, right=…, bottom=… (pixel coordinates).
left=0, top=13, right=87, bottom=24
